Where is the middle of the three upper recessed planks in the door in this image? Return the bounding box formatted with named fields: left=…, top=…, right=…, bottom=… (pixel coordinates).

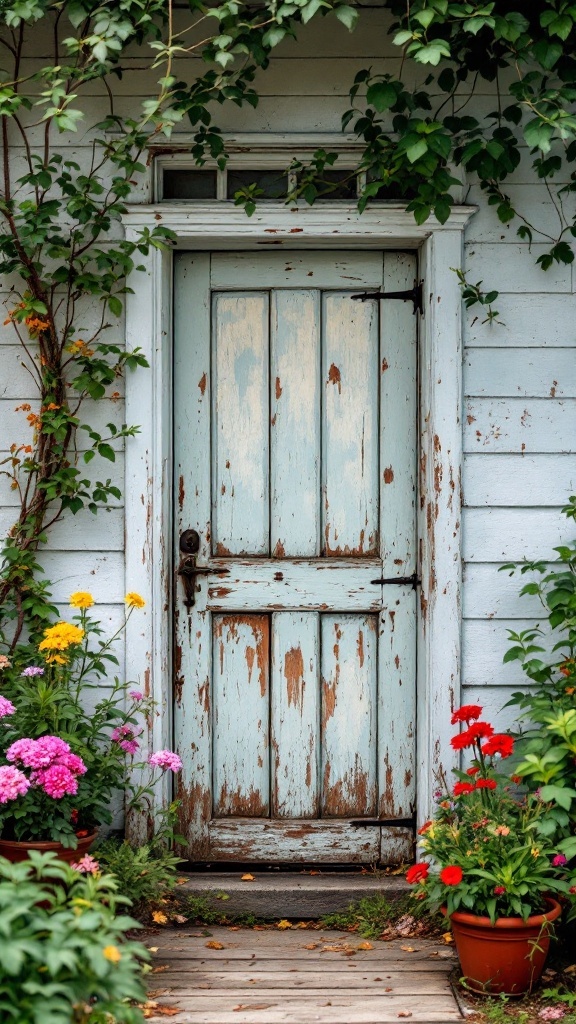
left=271, top=290, right=320, bottom=558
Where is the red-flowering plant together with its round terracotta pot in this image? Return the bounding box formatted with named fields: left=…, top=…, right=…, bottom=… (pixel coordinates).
left=407, top=705, right=570, bottom=995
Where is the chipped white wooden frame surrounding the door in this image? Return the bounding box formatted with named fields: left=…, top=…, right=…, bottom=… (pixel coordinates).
left=123, top=202, right=476, bottom=822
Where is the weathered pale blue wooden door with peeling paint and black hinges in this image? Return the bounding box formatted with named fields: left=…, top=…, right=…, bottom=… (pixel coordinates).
left=174, top=251, right=416, bottom=863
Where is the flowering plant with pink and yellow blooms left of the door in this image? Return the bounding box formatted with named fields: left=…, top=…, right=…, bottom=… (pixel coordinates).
left=0, top=591, right=181, bottom=848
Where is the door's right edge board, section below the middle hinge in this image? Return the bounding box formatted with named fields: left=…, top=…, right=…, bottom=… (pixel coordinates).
left=378, top=587, right=416, bottom=817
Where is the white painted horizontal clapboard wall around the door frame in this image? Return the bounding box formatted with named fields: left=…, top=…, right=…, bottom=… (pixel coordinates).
left=0, top=8, right=576, bottom=737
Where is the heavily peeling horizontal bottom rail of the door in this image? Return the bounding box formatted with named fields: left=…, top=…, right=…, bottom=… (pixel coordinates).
left=207, top=818, right=414, bottom=864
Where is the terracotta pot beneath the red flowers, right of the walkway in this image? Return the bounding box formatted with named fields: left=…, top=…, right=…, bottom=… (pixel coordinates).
left=450, top=898, right=562, bottom=995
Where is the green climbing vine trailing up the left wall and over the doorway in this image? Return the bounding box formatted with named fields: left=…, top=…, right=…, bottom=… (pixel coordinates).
left=0, top=0, right=576, bottom=645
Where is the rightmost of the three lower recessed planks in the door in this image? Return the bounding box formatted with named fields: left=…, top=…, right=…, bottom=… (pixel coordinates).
left=321, top=614, right=378, bottom=817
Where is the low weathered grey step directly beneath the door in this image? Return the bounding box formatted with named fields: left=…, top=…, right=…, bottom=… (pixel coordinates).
left=179, top=870, right=410, bottom=921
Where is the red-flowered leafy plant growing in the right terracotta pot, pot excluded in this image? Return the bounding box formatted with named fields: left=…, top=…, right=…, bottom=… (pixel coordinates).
left=406, top=705, right=572, bottom=923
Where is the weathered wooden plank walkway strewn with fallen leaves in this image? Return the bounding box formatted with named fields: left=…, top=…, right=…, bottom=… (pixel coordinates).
left=147, top=928, right=462, bottom=1024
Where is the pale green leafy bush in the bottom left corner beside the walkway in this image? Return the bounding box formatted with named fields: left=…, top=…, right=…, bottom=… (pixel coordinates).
left=0, top=853, right=150, bottom=1024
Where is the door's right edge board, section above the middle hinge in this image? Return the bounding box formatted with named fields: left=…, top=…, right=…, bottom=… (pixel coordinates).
left=379, top=253, right=417, bottom=577
